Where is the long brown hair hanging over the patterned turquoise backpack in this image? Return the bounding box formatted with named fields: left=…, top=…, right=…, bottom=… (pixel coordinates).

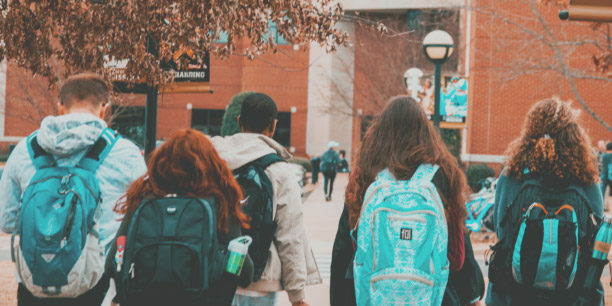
left=346, top=96, right=468, bottom=233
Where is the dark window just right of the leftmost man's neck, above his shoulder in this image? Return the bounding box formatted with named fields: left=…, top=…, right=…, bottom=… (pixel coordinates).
left=111, top=105, right=145, bottom=148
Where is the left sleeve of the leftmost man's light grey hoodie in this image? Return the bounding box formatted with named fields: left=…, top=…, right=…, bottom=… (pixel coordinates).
left=0, top=141, right=28, bottom=234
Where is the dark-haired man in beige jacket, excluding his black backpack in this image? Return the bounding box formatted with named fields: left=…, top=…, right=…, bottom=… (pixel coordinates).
left=211, top=93, right=321, bottom=306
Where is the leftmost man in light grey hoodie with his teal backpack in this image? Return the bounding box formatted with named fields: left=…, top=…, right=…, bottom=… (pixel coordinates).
left=0, top=74, right=146, bottom=306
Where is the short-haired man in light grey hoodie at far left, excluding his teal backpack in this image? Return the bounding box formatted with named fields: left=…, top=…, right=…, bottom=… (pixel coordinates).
left=0, top=74, right=147, bottom=305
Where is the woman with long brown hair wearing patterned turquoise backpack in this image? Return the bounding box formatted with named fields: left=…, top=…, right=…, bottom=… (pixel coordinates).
left=347, top=97, right=470, bottom=305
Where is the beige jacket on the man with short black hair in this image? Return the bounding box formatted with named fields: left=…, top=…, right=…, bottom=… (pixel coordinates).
left=211, top=133, right=322, bottom=303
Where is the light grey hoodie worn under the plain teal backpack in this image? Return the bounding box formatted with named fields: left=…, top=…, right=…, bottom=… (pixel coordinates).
left=0, top=113, right=147, bottom=251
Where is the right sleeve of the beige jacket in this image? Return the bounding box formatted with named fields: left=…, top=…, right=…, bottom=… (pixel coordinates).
left=268, top=163, right=307, bottom=303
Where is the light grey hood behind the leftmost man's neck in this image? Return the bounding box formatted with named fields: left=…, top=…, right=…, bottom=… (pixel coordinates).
left=36, top=113, right=107, bottom=157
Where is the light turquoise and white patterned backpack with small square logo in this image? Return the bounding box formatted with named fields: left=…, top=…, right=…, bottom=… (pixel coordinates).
left=354, top=164, right=449, bottom=305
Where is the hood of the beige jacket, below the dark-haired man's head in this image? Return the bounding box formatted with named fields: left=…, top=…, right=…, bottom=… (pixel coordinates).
left=211, top=133, right=291, bottom=170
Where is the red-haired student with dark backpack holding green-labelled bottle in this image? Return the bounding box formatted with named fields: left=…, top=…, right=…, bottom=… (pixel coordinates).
left=106, top=130, right=253, bottom=306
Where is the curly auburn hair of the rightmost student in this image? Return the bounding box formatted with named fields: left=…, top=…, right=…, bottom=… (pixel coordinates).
left=506, top=98, right=599, bottom=185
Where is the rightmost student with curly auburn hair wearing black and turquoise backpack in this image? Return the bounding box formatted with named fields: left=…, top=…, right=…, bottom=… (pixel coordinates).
left=486, top=99, right=607, bottom=305
